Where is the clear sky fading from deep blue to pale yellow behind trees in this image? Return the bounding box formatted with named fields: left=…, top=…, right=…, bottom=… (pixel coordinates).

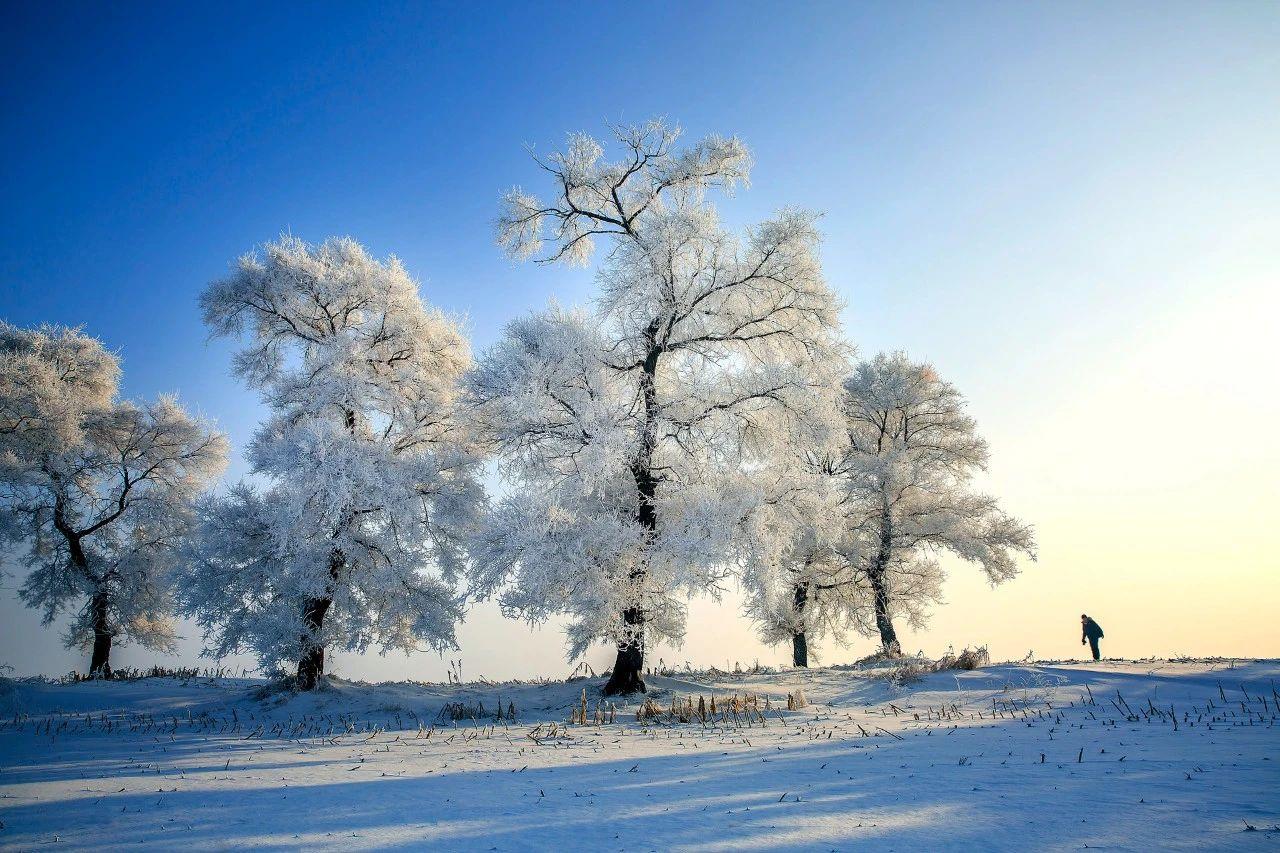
left=0, top=1, right=1280, bottom=679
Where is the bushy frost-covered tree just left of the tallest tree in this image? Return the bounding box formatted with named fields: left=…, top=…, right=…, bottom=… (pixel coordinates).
left=182, top=237, right=484, bottom=689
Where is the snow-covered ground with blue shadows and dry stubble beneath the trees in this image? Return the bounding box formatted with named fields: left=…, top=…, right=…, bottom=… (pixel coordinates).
left=0, top=661, right=1280, bottom=850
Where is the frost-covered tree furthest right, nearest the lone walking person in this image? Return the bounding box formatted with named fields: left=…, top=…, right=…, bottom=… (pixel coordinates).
left=831, top=352, right=1036, bottom=654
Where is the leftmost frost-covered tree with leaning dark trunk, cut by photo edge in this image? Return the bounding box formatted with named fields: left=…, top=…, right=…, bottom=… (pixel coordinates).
left=0, top=323, right=227, bottom=678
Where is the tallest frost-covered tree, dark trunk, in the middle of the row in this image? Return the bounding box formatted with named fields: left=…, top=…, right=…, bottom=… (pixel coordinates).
left=471, top=122, right=838, bottom=694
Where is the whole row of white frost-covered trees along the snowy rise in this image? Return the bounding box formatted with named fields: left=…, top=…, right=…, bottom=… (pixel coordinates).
left=0, top=120, right=1034, bottom=694
